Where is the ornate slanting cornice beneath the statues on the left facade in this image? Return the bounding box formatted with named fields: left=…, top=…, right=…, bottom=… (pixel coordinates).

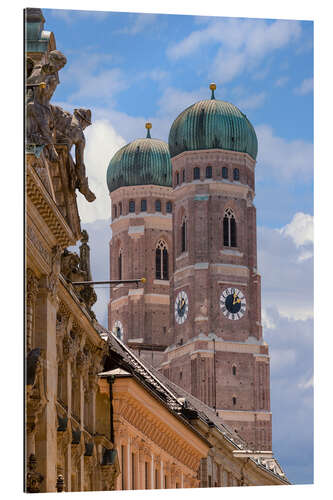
left=26, top=162, right=76, bottom=248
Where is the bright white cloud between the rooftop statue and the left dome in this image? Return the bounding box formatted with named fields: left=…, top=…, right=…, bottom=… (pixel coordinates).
left=77, top=120, right=125, bottom=223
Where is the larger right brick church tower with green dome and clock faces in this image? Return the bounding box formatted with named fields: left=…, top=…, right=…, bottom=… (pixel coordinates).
left=160, top=84, right=272, bottom=450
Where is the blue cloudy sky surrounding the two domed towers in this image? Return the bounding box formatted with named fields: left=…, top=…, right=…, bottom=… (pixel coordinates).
left=43, top=5, right=313, bottom=483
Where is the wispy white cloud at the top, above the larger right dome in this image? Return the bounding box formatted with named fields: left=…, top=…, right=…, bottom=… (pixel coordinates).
left=167, top=19, right=301, bottom=82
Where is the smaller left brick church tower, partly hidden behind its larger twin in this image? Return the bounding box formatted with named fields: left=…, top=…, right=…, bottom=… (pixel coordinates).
left=107, top=123, right=173, bottom=364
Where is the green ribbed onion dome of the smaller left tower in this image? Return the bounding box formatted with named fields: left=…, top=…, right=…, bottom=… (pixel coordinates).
left=106, top=123, right=172, bottom=193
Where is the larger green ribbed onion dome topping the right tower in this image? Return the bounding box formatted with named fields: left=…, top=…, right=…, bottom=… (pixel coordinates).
left=169, top=83, right=258, bottom=160
